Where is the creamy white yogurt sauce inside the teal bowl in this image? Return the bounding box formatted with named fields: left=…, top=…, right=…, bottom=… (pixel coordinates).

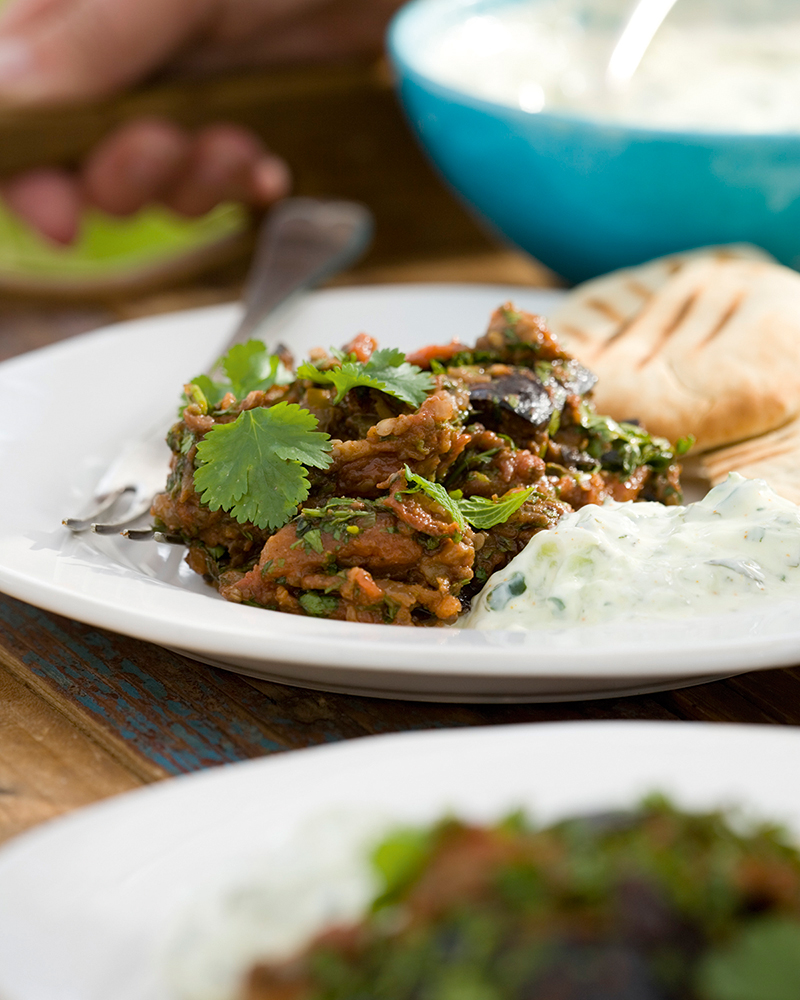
left=420, top=0, right=800, bottom=132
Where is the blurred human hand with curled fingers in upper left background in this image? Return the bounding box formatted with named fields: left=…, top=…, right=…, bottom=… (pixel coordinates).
left=0, top=0, right=398, bottom=243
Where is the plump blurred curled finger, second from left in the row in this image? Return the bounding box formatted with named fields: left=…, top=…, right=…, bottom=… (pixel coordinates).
left=83, top=119, right=192, bottom=215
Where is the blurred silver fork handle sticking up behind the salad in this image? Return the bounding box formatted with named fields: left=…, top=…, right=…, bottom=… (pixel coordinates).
left=222, top=198, right=373, bottom=354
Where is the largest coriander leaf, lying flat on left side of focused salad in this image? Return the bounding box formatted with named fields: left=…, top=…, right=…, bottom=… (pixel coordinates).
left=194, top=402, right=331, bottom=530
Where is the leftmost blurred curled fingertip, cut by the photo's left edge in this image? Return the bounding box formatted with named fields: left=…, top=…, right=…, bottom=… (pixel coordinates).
left=3, top=168, right=83, bottom=244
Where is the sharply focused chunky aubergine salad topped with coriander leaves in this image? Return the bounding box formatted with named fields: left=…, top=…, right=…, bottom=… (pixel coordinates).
left=152, top=305, right=688, bottom=625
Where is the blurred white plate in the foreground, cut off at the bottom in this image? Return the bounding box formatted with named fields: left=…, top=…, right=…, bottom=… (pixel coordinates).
left=0, top=722, right=800, bottom=1000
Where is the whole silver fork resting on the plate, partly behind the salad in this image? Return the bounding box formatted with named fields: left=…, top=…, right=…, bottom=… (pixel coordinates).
left=63, top=198, right=373, bottom=541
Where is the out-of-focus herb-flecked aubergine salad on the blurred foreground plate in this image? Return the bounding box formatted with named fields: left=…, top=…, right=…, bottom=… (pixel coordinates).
left=241, top=797, right=800, bottom=1000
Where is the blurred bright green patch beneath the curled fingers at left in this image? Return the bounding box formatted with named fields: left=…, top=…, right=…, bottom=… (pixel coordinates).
left=0, top=202, right=248, bottom=284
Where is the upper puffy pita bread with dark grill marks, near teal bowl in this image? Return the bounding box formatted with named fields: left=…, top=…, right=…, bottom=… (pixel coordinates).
left=550, top=248, right=800, bottom=451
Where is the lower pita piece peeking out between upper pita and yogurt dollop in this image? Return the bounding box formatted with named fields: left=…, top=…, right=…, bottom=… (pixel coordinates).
left=684, top=418, right=800, bottom=504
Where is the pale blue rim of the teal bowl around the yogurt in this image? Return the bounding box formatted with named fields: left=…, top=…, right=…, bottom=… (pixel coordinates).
left=386, top=0, right=800, bottom=146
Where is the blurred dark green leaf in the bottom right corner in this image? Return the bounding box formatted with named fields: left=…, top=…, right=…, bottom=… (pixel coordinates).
left=697, top=917, right=800, bottom=1000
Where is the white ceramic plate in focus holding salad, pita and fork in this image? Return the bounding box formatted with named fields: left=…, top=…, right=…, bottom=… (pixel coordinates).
left=0, top=285, right=800, bottom=701
